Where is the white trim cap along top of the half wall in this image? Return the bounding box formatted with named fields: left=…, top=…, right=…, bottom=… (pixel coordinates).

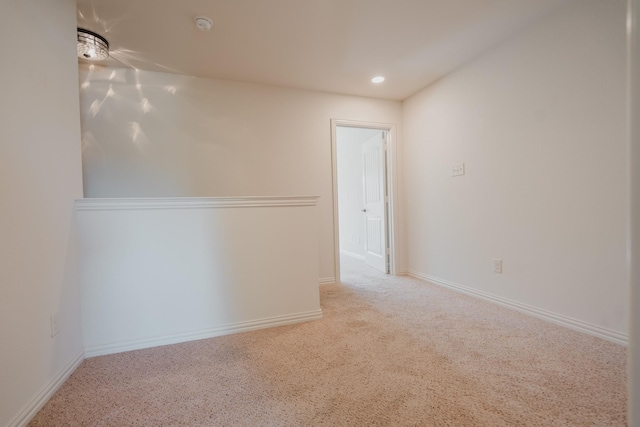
left=76, top=196, right=319, bottom=211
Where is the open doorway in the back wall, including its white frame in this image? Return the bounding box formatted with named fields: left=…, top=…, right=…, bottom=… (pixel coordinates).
left=331, top=120, right=395, bottom=281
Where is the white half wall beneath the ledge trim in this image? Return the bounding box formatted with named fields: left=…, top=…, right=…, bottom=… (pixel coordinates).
left=77, top=197, right=321, bottom=357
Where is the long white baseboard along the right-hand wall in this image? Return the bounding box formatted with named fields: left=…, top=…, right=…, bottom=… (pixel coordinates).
left=407, top=270, right=629, bottom=346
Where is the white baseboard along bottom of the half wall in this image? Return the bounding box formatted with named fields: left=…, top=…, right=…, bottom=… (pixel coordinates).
left=85, top=309, right=322, bottom=357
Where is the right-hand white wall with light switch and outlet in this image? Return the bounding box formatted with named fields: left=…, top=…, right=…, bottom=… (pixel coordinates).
left=402, top=0, right=628, bottom=341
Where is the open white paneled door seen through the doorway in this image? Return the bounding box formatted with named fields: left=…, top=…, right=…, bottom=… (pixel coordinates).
left=362, top=132, right=389, bottom=273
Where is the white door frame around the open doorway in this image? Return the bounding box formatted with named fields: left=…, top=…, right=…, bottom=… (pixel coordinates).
left=331, top=119, right=397, bottom=283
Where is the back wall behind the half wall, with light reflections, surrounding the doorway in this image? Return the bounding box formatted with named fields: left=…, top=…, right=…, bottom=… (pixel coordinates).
left=80, top=67, right=401, bottom=278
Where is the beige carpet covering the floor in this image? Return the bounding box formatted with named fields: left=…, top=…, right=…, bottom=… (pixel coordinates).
left=30, top=259, right=626, bottom=426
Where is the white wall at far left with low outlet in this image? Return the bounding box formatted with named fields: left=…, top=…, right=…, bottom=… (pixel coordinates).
left=0, top=0, right=83, bottom=426
